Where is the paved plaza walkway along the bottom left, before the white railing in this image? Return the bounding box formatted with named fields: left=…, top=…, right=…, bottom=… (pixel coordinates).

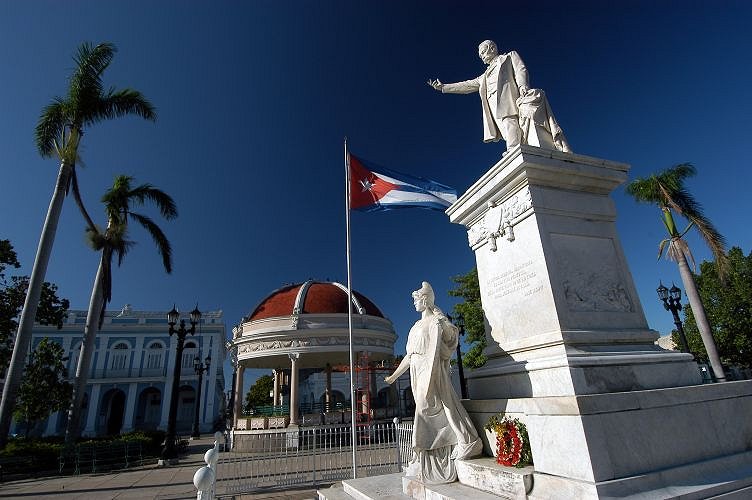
left=0, top=436, right=316, bottom=500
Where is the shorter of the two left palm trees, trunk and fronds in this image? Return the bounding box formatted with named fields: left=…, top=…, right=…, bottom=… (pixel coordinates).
left=65, top=175, right=178, bottom=443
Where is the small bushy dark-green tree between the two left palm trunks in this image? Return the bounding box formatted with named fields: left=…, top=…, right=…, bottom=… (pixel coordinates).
left=14, top=337, right=72, bottom=438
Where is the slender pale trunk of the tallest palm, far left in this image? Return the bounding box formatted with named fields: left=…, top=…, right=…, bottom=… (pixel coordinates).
left=0, top=161, right=71, bottom=448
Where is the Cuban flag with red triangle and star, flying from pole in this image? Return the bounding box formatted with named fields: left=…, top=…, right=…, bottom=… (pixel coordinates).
left=350, top=154, right=457, bottom=212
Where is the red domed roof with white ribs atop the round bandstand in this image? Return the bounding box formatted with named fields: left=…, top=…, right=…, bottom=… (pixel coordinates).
left=246, top=281, right=384, bottom=321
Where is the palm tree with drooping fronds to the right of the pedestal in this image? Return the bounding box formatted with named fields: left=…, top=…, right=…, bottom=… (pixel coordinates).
left=626, top=163, right=726, bottom=381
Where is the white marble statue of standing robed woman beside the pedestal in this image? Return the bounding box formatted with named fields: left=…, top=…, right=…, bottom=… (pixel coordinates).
left=385, top=281, right=483, bottom=484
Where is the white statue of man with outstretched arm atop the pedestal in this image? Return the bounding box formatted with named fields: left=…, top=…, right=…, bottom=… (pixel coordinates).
left=428, top=40, right=571, bottom=152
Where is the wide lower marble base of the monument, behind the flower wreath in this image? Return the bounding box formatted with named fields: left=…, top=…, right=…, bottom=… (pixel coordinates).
left=463, top=381, right=752, bottom=499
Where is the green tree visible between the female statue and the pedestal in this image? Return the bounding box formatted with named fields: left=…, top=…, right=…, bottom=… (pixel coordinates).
left=449, top=268, right=486, bottom=368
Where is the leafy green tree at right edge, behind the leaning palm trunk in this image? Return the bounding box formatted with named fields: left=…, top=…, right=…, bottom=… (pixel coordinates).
left=684, top=247, right=752, bottom=367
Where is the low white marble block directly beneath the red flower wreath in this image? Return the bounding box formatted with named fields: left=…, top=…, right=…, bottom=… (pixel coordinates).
left=454, top=457, right=533, bottom=498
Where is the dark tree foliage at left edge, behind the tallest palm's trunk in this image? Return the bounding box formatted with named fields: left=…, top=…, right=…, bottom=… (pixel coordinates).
left=0, top=240, right=69, bottom=371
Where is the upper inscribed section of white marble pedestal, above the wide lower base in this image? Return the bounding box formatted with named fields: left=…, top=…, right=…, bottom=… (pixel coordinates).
left=447, top=146, right=701, bottom=399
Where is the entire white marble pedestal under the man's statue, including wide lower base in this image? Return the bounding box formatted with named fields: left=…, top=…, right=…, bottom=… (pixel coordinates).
left=447, top=146, right=752, bottom=499
